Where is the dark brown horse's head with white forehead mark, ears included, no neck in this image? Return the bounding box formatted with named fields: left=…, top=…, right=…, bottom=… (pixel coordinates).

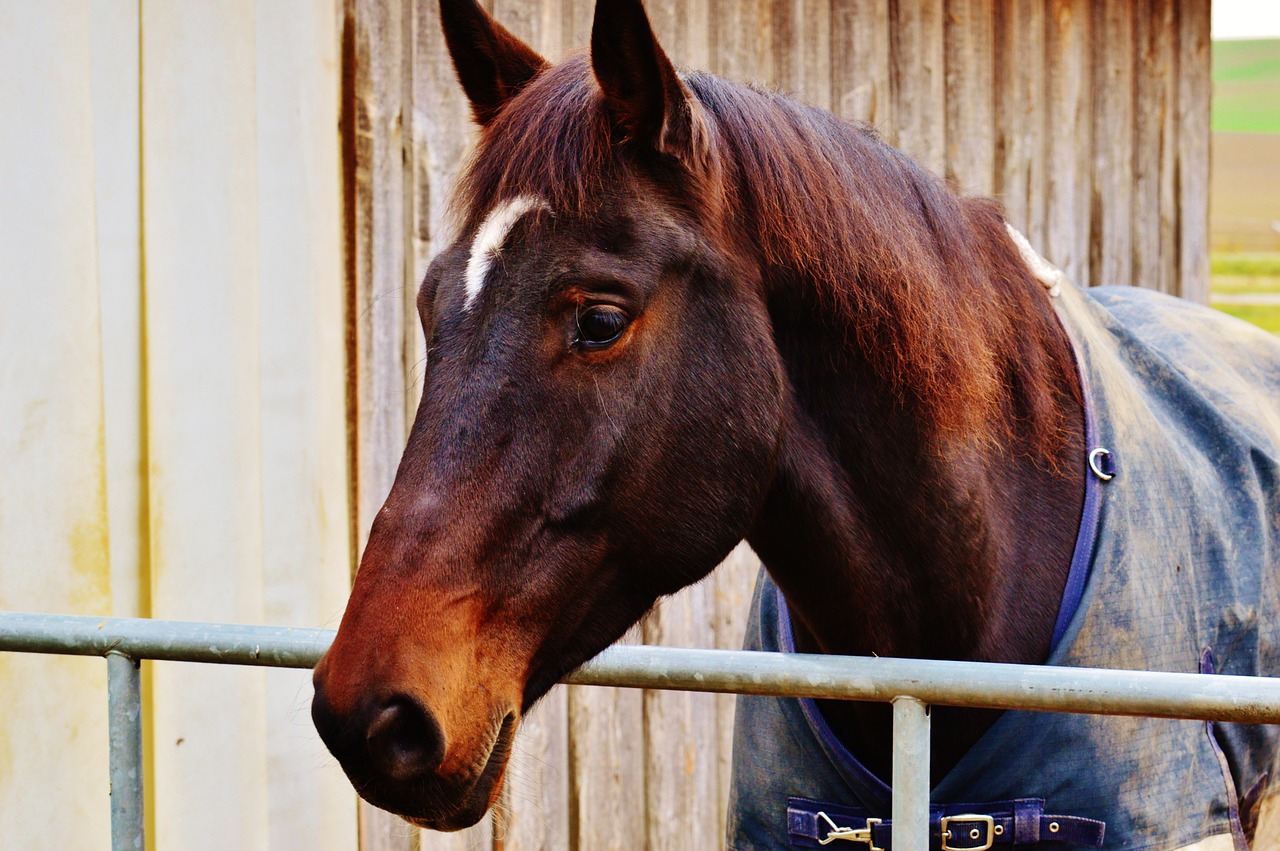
left=312, top=0, right=783, bottom=829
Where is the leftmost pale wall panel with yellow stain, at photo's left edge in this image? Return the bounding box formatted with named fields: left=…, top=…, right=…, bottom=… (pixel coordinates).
left=0, top=0, right=110, bottom=848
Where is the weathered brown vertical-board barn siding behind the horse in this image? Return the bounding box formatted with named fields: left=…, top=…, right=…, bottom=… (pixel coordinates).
left=342, top=0, right=1210, bottom=850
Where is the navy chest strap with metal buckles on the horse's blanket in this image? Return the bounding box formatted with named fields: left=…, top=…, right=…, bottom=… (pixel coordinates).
left=787, top=797, right=1107, bottom=851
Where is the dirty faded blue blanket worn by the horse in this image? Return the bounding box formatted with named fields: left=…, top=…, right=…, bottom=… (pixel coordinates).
left=728, top=266, right=1280, bottom=851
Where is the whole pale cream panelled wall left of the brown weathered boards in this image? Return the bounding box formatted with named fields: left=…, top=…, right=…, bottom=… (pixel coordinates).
left=0, top=0, right=356, bottom=850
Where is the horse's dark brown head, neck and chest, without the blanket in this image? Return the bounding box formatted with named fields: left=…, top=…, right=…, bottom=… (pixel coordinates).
left=314, top=0, right=1084, bottom=829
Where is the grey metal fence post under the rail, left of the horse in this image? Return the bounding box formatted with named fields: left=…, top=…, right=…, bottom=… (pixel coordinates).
left=106, top=650, right=145, bottom=851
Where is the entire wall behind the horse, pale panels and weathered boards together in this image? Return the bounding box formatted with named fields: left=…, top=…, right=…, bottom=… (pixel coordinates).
left=0, top=0, right=1210, bottom=851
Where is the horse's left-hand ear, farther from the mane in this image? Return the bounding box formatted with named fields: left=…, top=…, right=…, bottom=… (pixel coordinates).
left=440, top=0, right=547, bottom=127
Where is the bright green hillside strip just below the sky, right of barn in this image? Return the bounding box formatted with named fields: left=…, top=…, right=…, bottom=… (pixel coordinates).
left=1212, top=38, right=1280, bottom=133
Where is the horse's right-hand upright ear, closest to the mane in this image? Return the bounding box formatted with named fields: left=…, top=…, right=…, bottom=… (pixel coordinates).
left=591, top=0, right=701, bottom=159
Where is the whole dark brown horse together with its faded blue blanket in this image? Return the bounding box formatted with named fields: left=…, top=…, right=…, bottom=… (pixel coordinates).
left=312, top=0, right=1280, bottom=848
